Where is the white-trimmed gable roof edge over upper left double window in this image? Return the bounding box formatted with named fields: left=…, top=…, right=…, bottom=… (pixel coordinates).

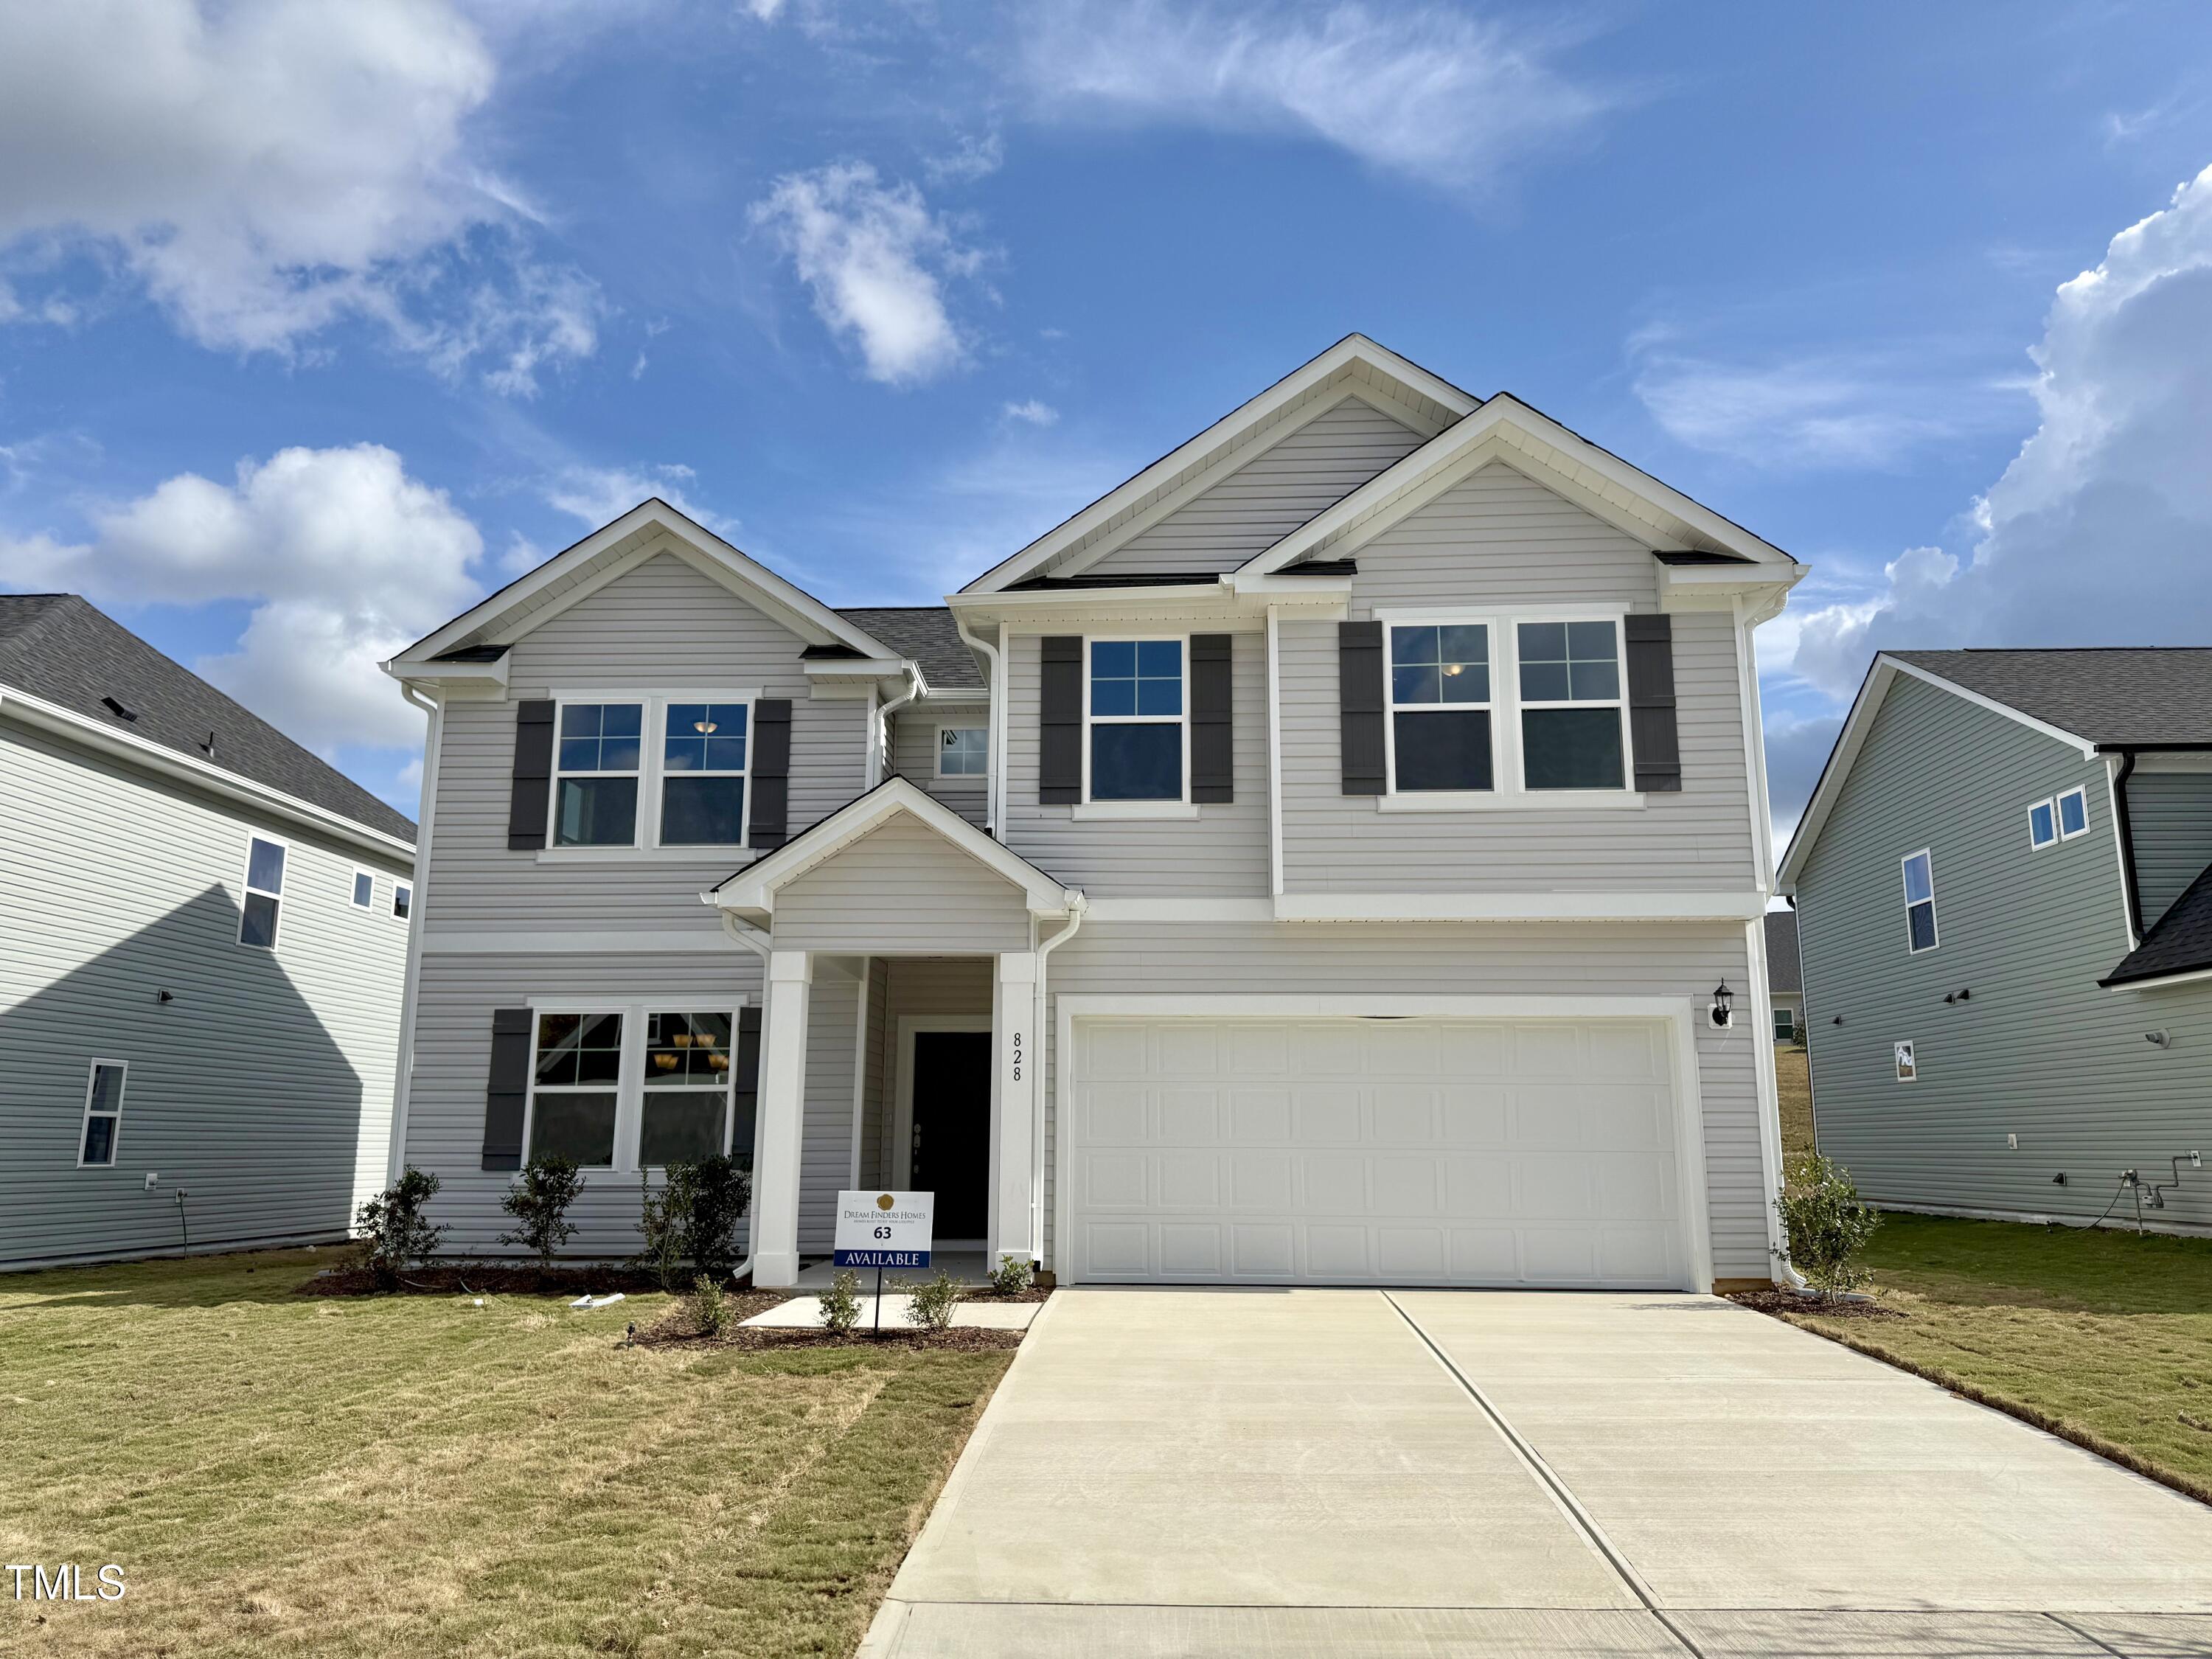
left=385, top=495, right=898, bottom=679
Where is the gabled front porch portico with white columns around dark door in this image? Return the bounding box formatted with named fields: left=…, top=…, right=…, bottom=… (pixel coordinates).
left=703, top=779, right=1084, bottom=1287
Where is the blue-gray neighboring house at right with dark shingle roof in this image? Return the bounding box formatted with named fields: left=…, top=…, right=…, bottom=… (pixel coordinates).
left=1783, top=648, right=2212, bottom=1228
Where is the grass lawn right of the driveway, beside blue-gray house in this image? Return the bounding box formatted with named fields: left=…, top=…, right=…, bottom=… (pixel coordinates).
left=1770, top=1214, right=2212, bottom=1502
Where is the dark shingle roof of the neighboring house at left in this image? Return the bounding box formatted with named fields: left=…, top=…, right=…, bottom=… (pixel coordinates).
left=0, top=593, right=416, bottom=847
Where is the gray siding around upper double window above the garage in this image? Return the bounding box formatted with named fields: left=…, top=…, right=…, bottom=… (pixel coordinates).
left=1276, top=465, right=1759, bottom=894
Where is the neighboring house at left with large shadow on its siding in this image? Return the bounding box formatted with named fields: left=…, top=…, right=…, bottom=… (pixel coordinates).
left=0, top=593, right=414, bottom=1267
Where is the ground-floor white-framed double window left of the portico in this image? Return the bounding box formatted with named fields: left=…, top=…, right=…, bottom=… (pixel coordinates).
left=524, top=998, right=752, bottom=1170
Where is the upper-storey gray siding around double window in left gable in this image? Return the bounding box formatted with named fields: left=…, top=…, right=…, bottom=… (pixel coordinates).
left=422, top=553, right=869, bottom=933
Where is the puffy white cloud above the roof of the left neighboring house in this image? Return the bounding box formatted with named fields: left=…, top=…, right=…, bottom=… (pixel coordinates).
left=0, top=445, right=482, bottom=754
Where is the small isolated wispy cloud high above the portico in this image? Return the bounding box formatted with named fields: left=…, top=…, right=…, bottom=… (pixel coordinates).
left=752, top=161, right=982, bottom=385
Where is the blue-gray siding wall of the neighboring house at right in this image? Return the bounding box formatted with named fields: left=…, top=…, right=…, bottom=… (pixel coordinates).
left=1796, top=675, right=2212, bottom=1225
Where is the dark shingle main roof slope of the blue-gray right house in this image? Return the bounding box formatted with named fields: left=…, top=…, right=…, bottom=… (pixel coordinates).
left=1887, top=646, right=2212, bottom=745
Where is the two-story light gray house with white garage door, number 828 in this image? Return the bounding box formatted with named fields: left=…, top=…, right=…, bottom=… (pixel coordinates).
left=387, top=336, right=1803, bottom=1287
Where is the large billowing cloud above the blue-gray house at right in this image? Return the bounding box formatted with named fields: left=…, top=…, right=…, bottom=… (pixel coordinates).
left=1792, top=168, right=2212, bottom=697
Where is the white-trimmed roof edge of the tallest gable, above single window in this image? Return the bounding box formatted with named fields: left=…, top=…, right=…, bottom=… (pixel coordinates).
left=960, top=334, right=1482, bottom=593
